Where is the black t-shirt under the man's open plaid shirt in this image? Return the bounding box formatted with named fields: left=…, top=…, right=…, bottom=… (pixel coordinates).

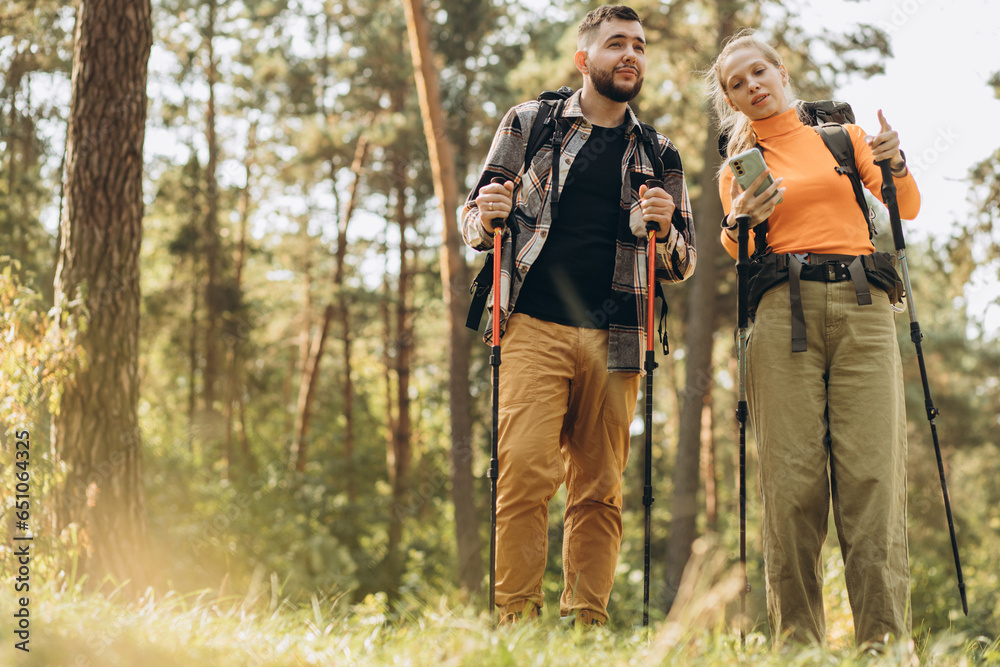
left=514, top=123, right=627, bottom=329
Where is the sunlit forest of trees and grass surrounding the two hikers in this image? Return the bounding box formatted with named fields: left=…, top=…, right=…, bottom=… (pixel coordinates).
left=0, top=0, right=1000, bottom=665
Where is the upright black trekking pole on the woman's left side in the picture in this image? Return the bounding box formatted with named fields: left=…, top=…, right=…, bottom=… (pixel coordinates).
left=736, top=215, right=750, bottom=646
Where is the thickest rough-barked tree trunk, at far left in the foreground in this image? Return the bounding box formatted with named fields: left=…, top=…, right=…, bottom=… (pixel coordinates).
left=51, top=0, right=152, bottom=591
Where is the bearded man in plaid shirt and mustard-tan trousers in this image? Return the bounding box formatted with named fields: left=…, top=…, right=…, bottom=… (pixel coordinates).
left=462, top=5, right=696, bottom=625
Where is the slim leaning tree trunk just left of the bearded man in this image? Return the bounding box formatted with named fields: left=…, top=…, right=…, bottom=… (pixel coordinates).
left=403, top=0, right=483, bottom=592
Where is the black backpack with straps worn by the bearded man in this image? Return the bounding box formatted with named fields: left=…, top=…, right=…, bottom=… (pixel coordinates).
left=465, top=86, right=668, bottom=354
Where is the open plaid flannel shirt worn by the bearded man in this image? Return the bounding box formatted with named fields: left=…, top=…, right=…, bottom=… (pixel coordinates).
left=461, top=90, right=697, bottom=372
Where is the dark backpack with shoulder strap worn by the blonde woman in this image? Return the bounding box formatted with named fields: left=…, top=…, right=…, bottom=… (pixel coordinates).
left=719, top=100, right=878, bottom=256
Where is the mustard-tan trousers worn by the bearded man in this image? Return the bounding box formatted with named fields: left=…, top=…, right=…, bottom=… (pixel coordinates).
left=496, top=313, right=639, bottom=619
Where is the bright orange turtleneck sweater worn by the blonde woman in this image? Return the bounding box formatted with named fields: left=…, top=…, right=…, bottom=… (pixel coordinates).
left=719, top=108, right=920, bottom=258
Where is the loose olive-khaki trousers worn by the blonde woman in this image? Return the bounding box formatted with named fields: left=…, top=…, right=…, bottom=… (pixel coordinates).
left=747, top=281, right=910, bottom=644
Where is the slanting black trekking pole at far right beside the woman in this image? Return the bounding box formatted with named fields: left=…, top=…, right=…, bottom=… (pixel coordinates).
left=876, top=160, right=969, bottom=616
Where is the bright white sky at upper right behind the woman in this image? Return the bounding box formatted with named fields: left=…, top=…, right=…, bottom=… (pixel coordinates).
left=788, top=0, right=1000, bottom=340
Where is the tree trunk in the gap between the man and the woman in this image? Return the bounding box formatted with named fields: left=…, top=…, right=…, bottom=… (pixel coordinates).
left=666, top=2, right=735, bottom=607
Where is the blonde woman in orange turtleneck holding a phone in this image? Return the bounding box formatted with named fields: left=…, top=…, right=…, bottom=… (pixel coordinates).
left=710, top=34, right=920, bottom=644
